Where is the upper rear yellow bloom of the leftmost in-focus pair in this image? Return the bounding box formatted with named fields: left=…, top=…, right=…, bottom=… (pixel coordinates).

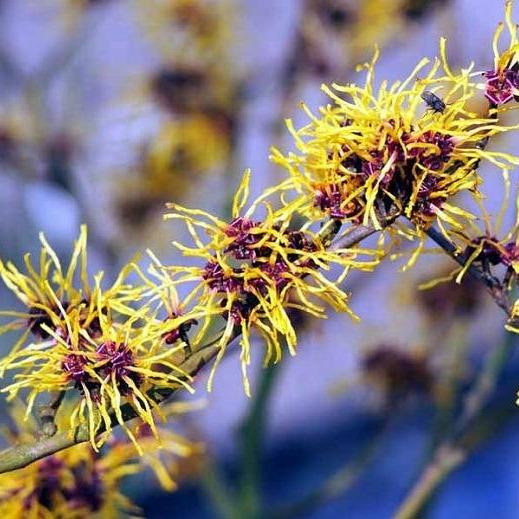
left=0, top=226, right=141, bottom=358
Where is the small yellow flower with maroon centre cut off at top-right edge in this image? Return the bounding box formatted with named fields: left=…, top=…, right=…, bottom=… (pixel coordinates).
left=484, top=0, right=519, bottom=107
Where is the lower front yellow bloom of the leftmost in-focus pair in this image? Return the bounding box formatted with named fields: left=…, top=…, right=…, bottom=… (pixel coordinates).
left=0, top=296, right=192, bottom=452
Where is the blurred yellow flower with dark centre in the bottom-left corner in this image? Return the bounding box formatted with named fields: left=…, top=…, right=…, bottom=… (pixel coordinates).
left=0, top=406, right=200, bottom=519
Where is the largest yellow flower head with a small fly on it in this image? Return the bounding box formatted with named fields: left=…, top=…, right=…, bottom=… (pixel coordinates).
left=271, top=40, right=519, bottom=236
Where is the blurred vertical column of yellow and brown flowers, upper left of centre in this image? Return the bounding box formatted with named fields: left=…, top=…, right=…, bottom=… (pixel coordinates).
left=110, top=0, right=240, bottom=237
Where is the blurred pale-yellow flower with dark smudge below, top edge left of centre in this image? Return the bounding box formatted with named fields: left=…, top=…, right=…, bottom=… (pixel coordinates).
left=135, top=0, right=242, bottom=124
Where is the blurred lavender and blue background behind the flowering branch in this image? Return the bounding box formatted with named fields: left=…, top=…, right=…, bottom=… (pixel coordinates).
left=0, top=0, right=519, bottom=519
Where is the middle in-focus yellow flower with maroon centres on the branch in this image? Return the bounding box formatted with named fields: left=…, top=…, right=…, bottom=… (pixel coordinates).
left=166, top=172, right=378, bottom=393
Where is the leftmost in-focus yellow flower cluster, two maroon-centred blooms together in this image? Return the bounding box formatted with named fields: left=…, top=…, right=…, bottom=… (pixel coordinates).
left=0, top=227, right=191, bottom=450
